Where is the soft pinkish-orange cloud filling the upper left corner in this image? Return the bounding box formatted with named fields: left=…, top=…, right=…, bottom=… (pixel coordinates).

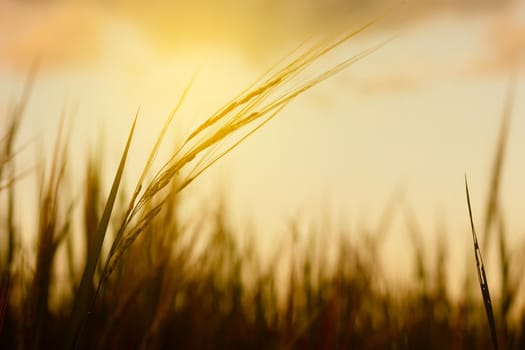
left=0, top=1, right=102, bottom=70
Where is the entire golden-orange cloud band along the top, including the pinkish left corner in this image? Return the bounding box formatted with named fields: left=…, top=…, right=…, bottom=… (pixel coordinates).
left=0, top=0, right=515, bottom=69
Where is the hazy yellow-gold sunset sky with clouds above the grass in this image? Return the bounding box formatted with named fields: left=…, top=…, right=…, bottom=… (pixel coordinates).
left=0, top=0, right=525, bottom=288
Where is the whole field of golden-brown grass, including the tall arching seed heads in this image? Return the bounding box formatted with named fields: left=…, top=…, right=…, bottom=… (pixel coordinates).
left=0, top=22, right=525, bottom=349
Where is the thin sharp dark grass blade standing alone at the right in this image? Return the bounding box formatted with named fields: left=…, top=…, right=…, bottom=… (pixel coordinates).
left=465, top=175, right=498, bottom=350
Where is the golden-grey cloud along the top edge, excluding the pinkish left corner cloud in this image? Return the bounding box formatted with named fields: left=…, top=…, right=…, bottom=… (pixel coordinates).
left=110, top=0, right=516, bottom=54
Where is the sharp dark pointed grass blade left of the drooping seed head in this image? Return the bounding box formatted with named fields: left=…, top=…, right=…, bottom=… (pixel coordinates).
left=64, top=111, right=138, bottom=349
